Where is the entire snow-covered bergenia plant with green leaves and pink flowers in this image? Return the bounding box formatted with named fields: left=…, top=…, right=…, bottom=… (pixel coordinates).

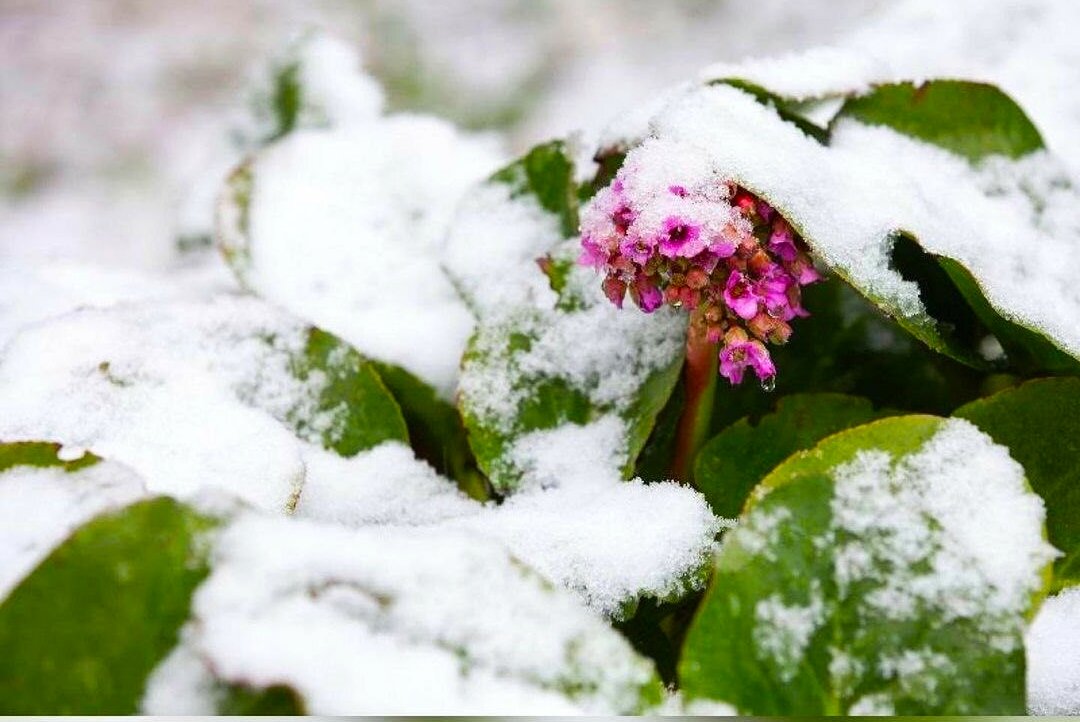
left=0, top=23, right=1080, bottom=716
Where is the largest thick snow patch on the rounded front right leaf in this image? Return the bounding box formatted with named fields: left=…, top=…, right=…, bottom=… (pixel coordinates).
left=832, top=419, right=1057, bottom=634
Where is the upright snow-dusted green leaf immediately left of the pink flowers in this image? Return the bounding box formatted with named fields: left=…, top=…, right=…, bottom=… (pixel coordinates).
left=448, top=144, right=686, bottom=492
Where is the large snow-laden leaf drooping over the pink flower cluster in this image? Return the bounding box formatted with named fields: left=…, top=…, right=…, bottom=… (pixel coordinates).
left=613, top=76, right=1080, bottom=370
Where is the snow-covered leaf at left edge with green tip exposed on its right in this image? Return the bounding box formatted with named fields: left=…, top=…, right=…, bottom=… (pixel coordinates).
left=0, top=296, right=408, bottom=510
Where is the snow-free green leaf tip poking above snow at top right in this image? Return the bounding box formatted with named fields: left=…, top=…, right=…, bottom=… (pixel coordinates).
left=835, top=80, right=1043, bottom=161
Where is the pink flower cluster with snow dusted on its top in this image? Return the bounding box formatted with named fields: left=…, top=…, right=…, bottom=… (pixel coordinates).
left=579, top=167, right=821, bottom=387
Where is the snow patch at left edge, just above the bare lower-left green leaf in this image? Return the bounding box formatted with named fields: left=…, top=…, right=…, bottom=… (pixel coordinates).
left=0, top=454, right=145, bottom=600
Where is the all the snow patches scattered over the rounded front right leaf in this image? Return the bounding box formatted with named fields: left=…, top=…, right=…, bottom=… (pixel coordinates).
left=725, top=419, right=1057, bottom=713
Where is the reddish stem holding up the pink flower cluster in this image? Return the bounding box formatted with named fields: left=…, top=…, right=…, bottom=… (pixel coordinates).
left=671, top=313, right=719, bottom=483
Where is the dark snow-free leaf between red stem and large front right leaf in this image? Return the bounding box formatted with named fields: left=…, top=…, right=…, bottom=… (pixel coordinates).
left=693, top=394, right=885, bottom=518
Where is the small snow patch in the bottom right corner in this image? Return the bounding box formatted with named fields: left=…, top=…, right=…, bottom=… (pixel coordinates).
left=1025, top=588, right=1080, bottom=714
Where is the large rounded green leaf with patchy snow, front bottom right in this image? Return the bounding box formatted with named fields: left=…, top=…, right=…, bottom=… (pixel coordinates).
left=679, top=417, right=1038, bottom=714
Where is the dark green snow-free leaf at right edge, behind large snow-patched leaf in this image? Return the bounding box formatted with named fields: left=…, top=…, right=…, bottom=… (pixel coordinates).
left=955, top=378, right=1080, bottom=590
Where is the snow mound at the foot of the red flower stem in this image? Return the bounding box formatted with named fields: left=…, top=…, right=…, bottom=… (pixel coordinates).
left=446, top=416, right=720, bottom=616
